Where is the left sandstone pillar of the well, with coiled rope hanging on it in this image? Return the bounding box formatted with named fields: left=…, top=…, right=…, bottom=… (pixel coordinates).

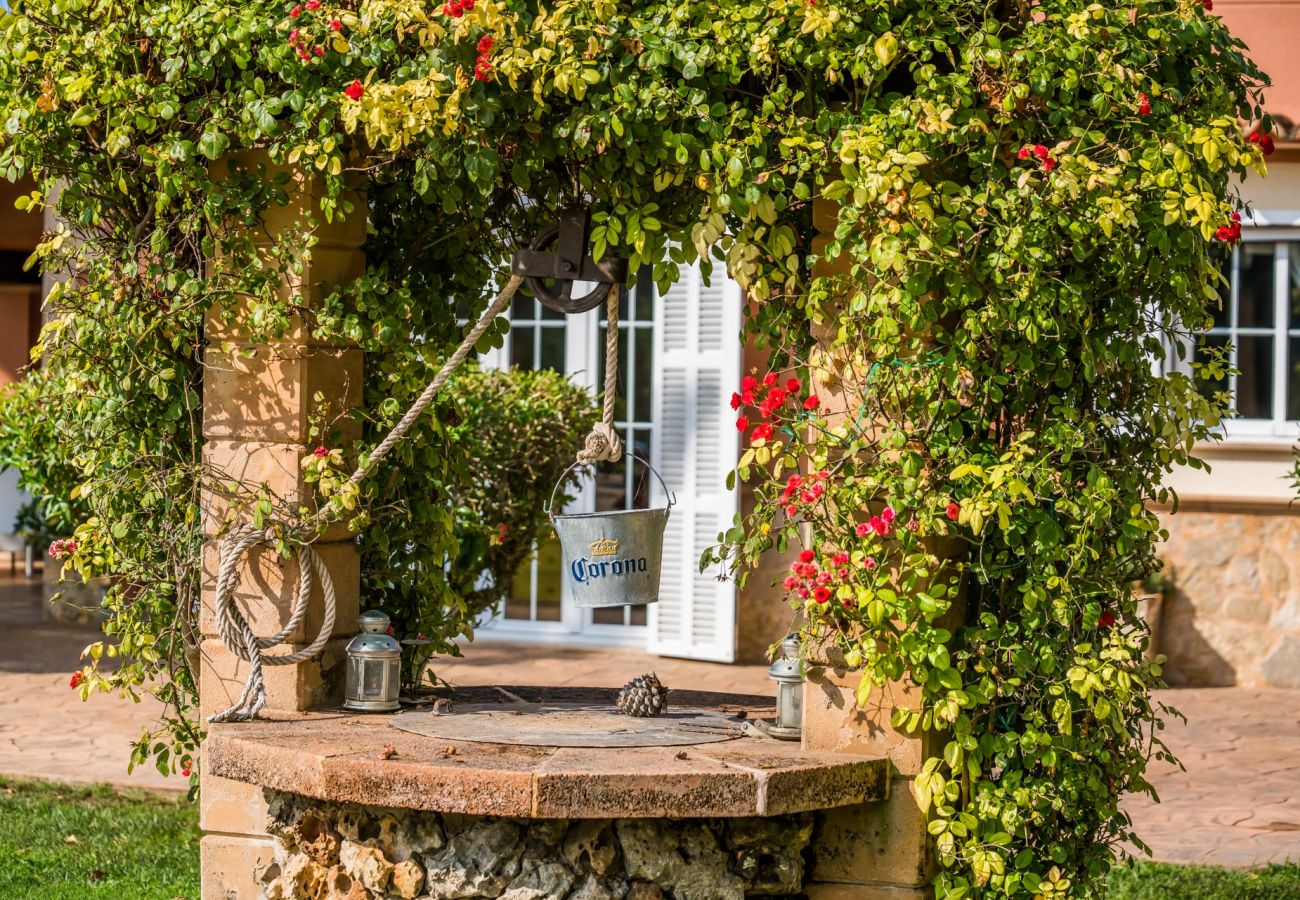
left=199, top=153, right=365, bottom=900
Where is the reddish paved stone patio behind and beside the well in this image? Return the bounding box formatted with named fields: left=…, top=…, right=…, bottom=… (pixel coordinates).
left=0, top=581, right=1300, bottom=866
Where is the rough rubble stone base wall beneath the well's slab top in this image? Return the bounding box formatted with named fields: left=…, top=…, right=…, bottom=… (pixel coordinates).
left=259, top=791, right=815, bottom=900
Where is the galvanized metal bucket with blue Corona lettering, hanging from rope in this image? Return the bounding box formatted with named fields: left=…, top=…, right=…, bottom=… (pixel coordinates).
left=547, top=455, right=676, bottom=609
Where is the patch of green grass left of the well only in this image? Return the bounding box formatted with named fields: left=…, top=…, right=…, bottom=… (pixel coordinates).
left=0, top=776, right=199, bottom=900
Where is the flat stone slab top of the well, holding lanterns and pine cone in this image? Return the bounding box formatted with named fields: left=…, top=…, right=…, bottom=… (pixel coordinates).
left=204, top=687, right=888, bottom=818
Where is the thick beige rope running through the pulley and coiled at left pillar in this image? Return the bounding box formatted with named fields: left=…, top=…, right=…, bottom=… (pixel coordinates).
left=208, top=274, right=623, bottom=722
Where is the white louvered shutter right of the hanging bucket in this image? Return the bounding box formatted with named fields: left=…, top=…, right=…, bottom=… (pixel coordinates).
left=649, top=265, right=744, bottom=662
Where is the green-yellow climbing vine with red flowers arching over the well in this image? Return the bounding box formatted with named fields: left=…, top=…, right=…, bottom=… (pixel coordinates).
left=0, top=0, right=1271, bottom=896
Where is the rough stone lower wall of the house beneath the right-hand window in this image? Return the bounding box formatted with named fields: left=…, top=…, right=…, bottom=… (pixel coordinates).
left=1158, top=506, right=1300, bottom=688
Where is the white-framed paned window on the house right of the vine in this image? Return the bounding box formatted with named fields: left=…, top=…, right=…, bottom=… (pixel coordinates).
left=1193, top=229, right=1300, bottom=440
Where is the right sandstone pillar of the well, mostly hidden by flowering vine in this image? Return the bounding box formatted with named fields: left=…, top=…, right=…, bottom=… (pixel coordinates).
left=802, top=198, right=965, bottom=900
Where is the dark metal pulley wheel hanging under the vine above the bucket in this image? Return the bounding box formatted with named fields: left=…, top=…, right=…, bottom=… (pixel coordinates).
left=510, top=209, right=628, bottom=315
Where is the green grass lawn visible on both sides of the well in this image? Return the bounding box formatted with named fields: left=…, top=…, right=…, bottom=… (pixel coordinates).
left=0, top=776, right=1300, bottom=900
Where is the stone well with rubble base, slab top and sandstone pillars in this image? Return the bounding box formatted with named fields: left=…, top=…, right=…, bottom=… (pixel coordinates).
left=199, top=169, right=931, bottom=900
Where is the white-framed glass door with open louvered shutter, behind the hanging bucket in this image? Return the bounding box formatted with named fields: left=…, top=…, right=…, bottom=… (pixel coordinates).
left=480, top=260, right=744, bottom=652
